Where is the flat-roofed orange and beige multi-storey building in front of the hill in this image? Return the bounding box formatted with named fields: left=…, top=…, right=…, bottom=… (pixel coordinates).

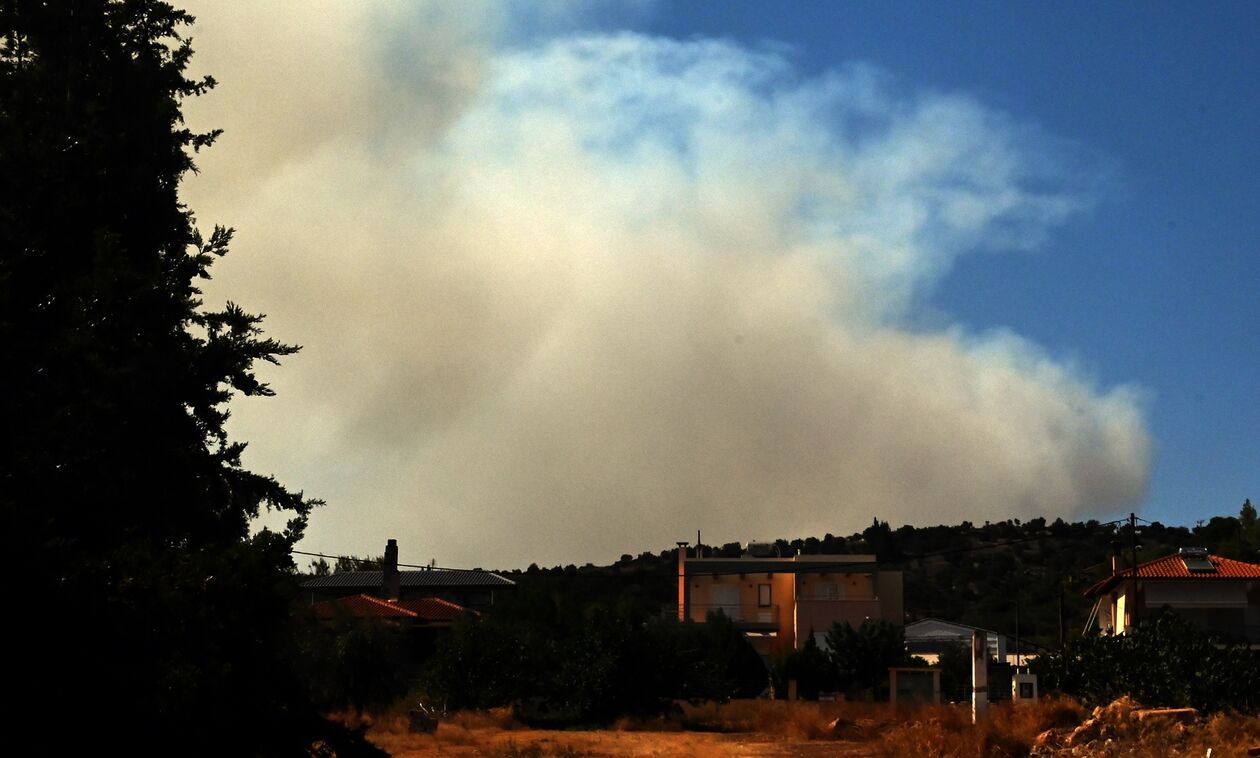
left=678, top=543, right=903, bottom=657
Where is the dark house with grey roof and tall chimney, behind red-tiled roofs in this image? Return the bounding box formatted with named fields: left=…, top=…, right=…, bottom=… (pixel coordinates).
left=301, top=540, right=517, bottom=611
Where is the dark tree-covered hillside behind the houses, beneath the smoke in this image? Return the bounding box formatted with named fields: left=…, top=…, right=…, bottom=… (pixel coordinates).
left=504, top=501, right=1260, bottom=647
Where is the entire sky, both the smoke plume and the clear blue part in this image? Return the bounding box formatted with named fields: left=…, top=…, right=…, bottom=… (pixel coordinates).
left=184, top=1, right=1260, bottom=568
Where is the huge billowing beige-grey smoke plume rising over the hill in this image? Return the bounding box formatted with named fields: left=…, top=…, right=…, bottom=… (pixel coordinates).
left=186, top=4, right=1150, bottom=567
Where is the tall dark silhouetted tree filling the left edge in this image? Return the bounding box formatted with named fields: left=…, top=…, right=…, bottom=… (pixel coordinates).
left=0, top=0, right=357, bottom=754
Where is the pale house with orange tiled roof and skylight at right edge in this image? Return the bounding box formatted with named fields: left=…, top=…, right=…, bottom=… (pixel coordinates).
left=1085, top=548, right=1260, bottom=643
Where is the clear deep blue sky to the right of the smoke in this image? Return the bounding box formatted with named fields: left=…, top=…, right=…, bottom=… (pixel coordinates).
left=630, top=3, right=1260, bottom=524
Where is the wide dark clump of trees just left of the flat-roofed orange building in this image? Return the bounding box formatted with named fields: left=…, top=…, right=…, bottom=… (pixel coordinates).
left=426, top=589, right=767, bottom=723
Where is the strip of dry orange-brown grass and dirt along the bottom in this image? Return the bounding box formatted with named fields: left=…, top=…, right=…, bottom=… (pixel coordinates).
left=332, top=699, right=1260, bottom=758
